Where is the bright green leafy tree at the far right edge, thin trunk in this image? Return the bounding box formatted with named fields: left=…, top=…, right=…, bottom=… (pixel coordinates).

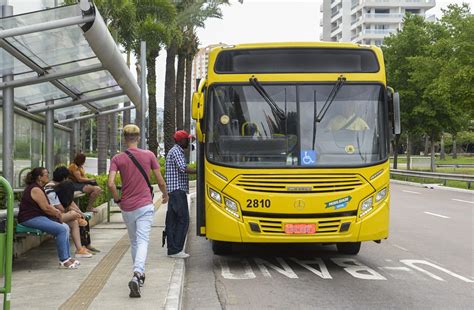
left=409, top=4, right=474, bottom=171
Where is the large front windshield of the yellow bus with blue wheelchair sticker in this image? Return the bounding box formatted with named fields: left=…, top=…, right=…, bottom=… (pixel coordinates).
left=206, top=83, right=388, bottom=168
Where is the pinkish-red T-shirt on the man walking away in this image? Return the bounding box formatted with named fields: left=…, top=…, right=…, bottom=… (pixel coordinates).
left=110, top=148, right=160, bottom=211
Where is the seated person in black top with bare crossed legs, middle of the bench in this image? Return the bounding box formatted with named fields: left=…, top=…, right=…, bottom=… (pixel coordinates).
left=44, top=166, right=96, bottom=258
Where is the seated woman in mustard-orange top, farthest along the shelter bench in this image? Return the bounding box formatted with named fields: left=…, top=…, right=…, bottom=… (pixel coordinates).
left=69, top=153, right=102, bottom=212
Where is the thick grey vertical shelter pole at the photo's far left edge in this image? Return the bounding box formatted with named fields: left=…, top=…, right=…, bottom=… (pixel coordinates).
left=0, top=5, right=15, bottom=185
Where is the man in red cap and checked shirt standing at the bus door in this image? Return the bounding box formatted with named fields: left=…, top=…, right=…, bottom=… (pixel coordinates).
left=165, top=130, right=196, bottom=258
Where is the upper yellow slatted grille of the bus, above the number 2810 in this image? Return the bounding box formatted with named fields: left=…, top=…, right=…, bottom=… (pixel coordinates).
left=235, top=174, right=364, bottom=194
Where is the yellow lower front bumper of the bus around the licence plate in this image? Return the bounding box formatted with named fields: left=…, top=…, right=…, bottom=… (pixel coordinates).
left=206, top=199, right=389, bottom=243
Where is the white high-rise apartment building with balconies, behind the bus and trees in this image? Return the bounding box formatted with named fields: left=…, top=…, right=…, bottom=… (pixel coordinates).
left=320, top=0, right=436, bottom=45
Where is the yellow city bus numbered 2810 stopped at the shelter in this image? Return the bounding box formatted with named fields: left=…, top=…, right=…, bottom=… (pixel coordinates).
left=192, top=42, right=400, bottom=255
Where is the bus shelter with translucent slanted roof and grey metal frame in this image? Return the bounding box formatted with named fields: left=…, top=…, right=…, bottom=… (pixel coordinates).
left=0, top=0, right=145, bottom=184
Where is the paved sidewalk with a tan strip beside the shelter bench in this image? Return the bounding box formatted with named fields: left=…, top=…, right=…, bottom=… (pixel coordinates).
left=0, top=194, right=184, bottom=309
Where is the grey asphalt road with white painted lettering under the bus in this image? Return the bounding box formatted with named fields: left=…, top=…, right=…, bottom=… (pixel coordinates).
left=183, top=184, right=474, bottom=309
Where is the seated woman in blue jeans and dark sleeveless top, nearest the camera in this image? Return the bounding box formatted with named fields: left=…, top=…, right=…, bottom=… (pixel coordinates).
left=18, top=167, right=80, bottom=269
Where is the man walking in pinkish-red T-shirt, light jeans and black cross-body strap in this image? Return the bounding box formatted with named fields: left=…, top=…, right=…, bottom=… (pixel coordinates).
left=107, top=124, right=168, bottom=297
